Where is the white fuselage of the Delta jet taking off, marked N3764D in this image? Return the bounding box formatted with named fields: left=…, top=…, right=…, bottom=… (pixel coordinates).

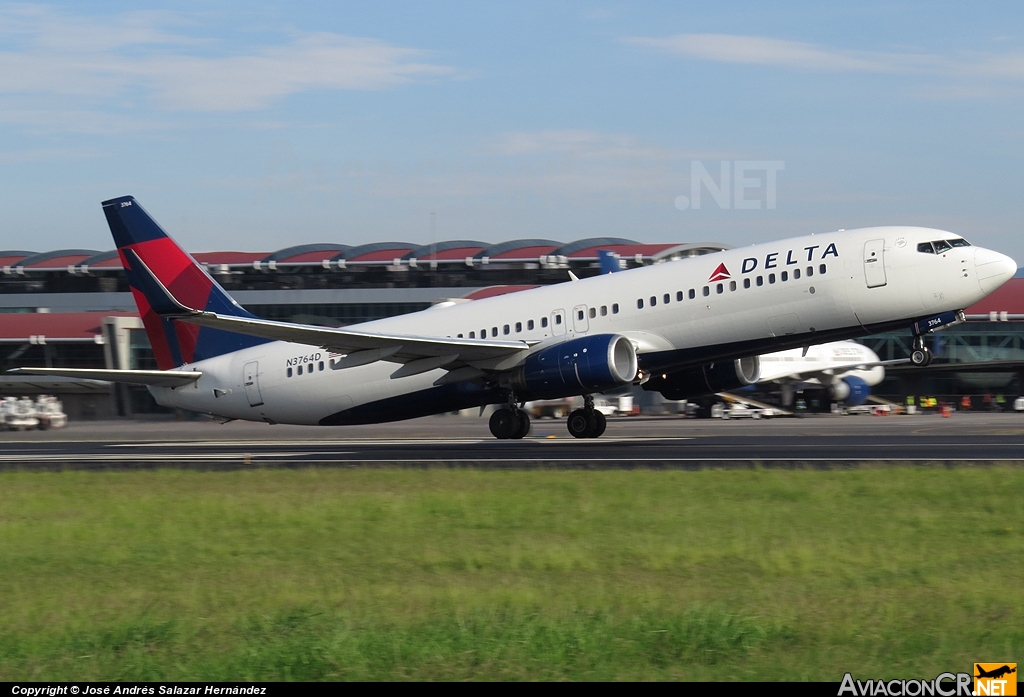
left=150, top=227, right=1016, bottom=424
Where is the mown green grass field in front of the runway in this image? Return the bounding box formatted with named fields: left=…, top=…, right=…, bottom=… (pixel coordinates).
left=0, top=467, right=1024, bottom=681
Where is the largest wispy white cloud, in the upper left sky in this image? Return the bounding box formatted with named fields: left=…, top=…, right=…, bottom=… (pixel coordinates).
left=0, top=5, right=457, bottom=112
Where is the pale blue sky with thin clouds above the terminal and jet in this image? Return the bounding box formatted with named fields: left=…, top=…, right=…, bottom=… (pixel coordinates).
left=0, top=1, right=1024, bottom=261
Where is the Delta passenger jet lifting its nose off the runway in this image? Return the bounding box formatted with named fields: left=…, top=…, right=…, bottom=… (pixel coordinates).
left=12, top=197, right=1017, bottom=438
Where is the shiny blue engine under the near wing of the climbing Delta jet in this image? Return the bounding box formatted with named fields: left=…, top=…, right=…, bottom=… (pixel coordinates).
left=512, top=334, right=637, bottom=399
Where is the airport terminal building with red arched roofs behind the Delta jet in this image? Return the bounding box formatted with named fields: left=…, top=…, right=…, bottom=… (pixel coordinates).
left=0, top=237, right=1024, bottom=419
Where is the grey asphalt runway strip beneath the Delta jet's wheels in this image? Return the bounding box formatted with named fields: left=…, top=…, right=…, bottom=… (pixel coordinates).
left=0, top=413, right=1024, bottom=470
